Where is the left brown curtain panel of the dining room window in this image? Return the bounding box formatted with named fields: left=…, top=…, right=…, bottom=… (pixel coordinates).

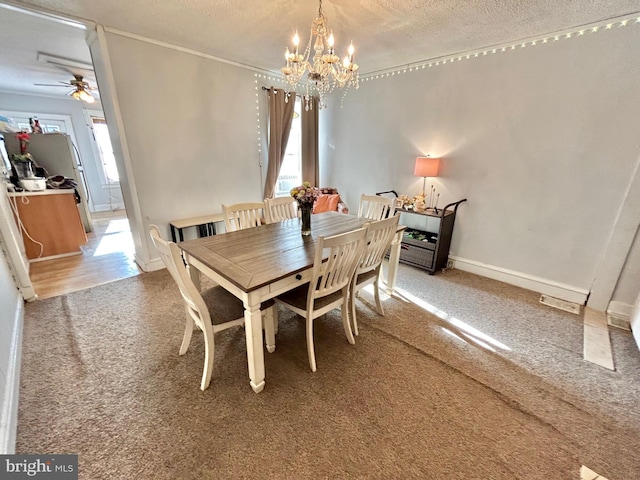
left=264, top=87, right=296, bottom=198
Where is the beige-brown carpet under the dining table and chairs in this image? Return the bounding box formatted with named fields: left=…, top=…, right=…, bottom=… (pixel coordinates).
left=17, top=266, right=640, bottom=480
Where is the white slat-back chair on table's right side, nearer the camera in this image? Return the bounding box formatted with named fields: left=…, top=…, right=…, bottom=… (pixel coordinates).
left=276, top=228, right=367, bottom=372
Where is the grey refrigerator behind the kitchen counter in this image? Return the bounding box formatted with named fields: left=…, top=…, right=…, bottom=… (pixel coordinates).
left=4, top=132, right=93, bottom=232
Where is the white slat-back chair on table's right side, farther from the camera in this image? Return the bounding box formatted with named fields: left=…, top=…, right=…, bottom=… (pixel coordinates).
left=349, top=215, right=400, bottom=335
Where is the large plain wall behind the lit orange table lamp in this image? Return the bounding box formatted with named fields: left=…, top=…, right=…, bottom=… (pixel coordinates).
left=321, top=23, right=640, bottom=303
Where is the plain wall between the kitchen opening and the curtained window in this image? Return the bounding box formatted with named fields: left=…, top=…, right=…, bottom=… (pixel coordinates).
left=92, top=32, right=262, bottom=268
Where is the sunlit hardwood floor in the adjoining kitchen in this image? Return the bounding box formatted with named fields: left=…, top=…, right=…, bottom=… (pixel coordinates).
left=30, top=210, right=142, bottom=299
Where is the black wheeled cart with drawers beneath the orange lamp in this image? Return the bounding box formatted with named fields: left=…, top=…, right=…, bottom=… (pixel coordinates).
left=396, top=198, right=467, bottom=275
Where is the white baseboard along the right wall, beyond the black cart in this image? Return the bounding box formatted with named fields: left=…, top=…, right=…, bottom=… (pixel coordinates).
left=449, top=256, right=589, bottom=305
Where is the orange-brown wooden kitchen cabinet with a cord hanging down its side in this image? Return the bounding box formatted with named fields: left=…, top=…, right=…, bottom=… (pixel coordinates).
left=10, top=190, right=87, bottom=260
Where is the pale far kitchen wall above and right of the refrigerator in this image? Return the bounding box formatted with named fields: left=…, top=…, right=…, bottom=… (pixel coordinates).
left=0, top=92, right=122, bottom=211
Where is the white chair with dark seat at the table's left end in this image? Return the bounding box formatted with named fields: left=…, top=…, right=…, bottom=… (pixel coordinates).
left=149, top=224, right=277, bottom=390
